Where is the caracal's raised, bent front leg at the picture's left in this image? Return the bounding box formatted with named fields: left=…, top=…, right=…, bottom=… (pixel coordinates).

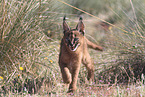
left=59, top=63, right=72, bottom=84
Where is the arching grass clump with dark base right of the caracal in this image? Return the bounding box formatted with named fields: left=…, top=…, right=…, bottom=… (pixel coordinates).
left=93, top=0, right=145, bottom=83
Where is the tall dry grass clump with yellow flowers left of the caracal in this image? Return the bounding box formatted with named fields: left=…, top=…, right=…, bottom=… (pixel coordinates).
left=0, top=0, right=59, bottom=93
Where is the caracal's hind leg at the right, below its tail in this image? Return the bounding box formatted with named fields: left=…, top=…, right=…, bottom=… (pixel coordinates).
left=82, top=52, right=94, bottom=81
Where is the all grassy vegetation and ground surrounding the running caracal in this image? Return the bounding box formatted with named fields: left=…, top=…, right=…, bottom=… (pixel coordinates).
left=0, top=0, right=145, bottom=96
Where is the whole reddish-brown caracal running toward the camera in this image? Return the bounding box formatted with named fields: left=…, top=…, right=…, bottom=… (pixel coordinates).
left=59, top=17, right=103, bottom=92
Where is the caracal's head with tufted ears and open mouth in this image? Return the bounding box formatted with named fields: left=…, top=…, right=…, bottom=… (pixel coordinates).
left=63, top=17, right=85, bottom=51
